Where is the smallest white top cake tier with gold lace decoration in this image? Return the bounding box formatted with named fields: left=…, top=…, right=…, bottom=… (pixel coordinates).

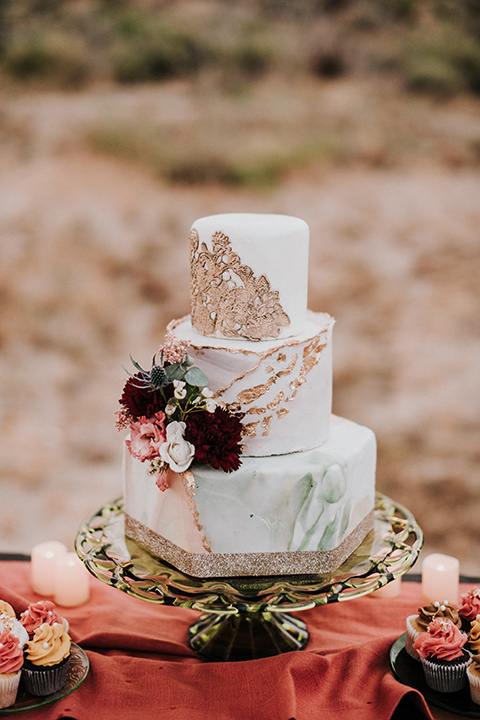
left=190, top=213, right=309, bottom=341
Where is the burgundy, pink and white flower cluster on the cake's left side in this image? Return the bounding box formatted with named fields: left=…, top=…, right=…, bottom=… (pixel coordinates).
left=116, top=334, right=243, bottom=490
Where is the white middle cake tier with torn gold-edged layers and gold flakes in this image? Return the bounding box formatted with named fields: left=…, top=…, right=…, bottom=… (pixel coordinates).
left=167, top=312, right=335, bottom=456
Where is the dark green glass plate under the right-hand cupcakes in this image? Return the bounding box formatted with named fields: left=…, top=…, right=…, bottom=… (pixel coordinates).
left=390, top=633, right=480, bottom=718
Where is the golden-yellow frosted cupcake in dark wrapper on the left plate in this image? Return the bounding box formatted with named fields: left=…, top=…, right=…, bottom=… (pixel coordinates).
left=22, top=622, right=71, bottom=695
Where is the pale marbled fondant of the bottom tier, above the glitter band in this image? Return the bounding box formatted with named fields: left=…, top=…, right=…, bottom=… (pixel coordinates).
left=125, top=416, right=376, bottom=553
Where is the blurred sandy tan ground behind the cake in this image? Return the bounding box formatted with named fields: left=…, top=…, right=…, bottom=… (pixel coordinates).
left=0, top=74, right=480, bottom=574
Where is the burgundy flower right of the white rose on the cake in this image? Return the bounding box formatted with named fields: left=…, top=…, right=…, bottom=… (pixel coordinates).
left=185, top=406, right=242, bottom=472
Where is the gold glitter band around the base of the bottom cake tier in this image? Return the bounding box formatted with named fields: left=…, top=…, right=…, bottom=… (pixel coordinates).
left=125, top=510, right=373, bottom=578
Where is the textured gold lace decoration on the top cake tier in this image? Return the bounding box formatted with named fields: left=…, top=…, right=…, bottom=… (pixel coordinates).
left=190, top=228, right=290, bottom=340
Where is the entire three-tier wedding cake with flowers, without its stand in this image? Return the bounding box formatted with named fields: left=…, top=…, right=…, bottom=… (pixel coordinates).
left=118, top=214, right=376, bottom=577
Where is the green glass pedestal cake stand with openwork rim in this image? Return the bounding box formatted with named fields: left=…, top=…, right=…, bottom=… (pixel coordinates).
left=75, top=493, right=423, bottom=661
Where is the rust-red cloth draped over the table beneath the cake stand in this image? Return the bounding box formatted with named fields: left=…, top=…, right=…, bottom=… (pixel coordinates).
left=0, top=561, right=467, bottom=720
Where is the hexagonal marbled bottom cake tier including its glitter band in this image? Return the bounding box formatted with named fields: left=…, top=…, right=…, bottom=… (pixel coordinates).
left=124, top=416, right=376, bottom=577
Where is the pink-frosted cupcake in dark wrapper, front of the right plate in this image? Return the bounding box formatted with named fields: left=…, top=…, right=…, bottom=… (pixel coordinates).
left=414, top=618, right=471, bottom=693
